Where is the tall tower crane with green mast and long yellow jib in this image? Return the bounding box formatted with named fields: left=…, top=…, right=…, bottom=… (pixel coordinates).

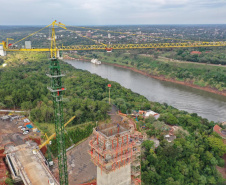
left=0, top=21, right=226, bottom=185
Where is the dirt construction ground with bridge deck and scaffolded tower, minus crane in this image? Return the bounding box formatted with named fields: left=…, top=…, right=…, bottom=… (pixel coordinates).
left=0, top=108, right=143, bottom=185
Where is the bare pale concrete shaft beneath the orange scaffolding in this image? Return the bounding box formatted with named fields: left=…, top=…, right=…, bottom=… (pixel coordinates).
left=97, top=164, right=131, bottom=185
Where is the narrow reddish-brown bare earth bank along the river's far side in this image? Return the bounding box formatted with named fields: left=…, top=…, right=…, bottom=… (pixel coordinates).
left=102, top=62, right=226, bottom=96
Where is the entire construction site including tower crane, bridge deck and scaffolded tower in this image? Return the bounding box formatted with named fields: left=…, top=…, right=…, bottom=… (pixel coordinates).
left=0, top=21, right=226, bottom=185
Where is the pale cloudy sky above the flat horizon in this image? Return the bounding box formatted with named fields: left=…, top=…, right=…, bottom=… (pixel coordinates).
left=0, top=0, right=226, bottom=25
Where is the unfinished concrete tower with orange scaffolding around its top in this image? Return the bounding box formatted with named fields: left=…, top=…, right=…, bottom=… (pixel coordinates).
left=89, top=122, right=141, bottom=185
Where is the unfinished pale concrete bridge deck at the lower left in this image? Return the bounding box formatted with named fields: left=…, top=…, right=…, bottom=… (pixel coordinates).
left=5, top=141, right=59, bottom=185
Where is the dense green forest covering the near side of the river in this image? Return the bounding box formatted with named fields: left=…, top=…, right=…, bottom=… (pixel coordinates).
left=0, top=53, right=226, bottom=185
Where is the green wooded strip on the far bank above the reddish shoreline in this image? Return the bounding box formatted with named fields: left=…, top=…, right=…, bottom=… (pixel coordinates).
left=86, top=51, right=226, bottom=91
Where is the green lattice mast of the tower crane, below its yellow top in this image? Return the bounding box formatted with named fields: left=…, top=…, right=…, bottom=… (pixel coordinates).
left=47, top=58, right=68, bottom=185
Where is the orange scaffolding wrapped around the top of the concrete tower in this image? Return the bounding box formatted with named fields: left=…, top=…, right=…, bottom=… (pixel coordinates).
left=89, top=122, right=141, bottom=184
